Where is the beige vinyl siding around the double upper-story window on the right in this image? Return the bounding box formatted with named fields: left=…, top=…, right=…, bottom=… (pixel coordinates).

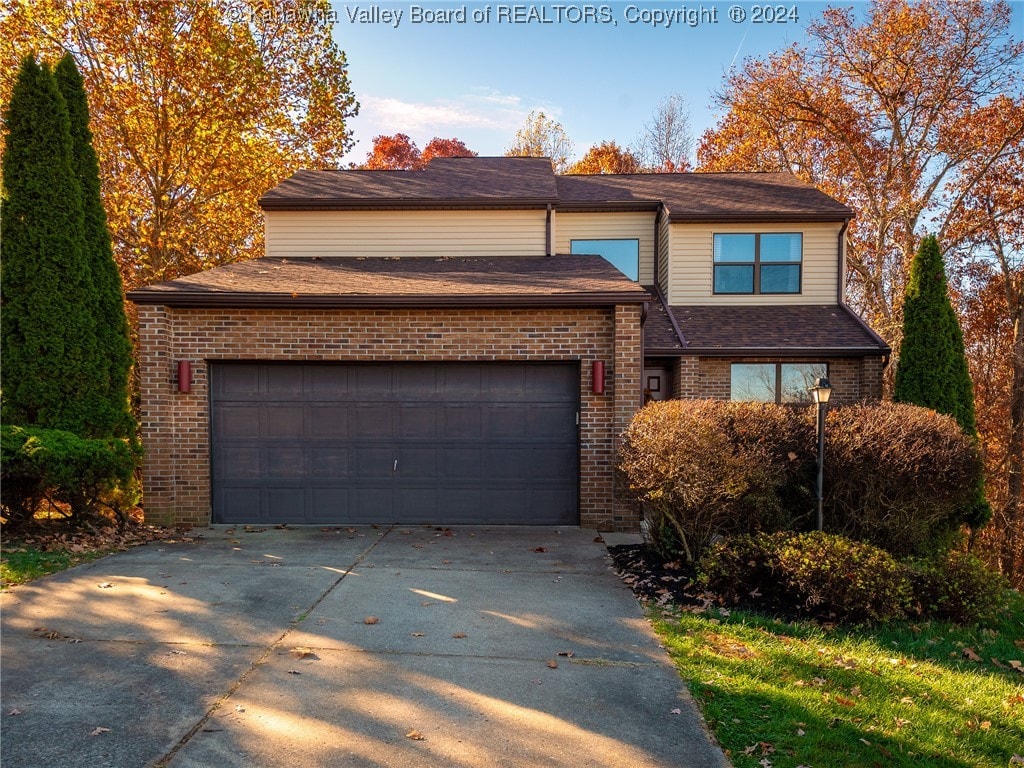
left=668, top=222, right=843, bottom=305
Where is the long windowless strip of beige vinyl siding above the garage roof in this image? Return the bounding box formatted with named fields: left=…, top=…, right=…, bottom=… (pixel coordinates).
left=263, top=210, right=547, bottom=258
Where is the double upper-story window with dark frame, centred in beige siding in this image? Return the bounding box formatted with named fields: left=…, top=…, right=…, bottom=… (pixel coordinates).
left=715, top=232, right=804, bottom=294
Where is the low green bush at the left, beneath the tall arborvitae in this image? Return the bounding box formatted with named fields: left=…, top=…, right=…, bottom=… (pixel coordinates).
left=0, top=425, right=141, bottom=523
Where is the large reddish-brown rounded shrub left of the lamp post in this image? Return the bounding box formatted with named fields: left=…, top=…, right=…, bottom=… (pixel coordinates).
left=620, top=400, right=814, bottom=562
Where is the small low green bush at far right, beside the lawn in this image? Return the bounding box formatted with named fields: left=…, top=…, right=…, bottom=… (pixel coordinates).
left=910, top=552, right=1010, bottom=624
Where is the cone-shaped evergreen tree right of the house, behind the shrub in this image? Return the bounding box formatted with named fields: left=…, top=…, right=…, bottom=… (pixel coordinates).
left=893, top=234, right=977, bottom=435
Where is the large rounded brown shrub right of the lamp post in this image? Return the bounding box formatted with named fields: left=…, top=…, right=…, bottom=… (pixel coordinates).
left=824, top=402, right=982, bottom=557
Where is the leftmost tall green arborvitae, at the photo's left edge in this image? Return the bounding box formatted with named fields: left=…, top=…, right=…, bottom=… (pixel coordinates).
left=0, top=56, right=102, bottom=436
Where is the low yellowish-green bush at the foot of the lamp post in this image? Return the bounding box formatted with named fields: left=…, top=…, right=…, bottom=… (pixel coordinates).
left=698, top=531, right=911, bottom=624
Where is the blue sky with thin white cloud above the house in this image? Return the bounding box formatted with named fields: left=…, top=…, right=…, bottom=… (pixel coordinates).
left=332, top=0, right=1024, bottom=162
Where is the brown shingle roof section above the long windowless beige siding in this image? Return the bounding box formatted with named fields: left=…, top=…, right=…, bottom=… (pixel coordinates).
left=259, top=158, right=558, bottom=210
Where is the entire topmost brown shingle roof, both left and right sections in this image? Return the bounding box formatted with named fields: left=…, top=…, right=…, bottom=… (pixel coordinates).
left=259, top=158, right=853, bottom=222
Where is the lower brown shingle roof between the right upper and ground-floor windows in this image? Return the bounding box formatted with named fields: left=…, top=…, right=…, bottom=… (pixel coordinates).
left=670, top=304, right=890, bottom=355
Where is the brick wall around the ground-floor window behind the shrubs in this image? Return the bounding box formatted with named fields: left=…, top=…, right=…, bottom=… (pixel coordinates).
left=675, top=356, right=883, bottom=403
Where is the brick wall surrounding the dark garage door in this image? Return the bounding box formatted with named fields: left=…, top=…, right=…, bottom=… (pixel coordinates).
left=139, top=305, right=641, bottom=530
